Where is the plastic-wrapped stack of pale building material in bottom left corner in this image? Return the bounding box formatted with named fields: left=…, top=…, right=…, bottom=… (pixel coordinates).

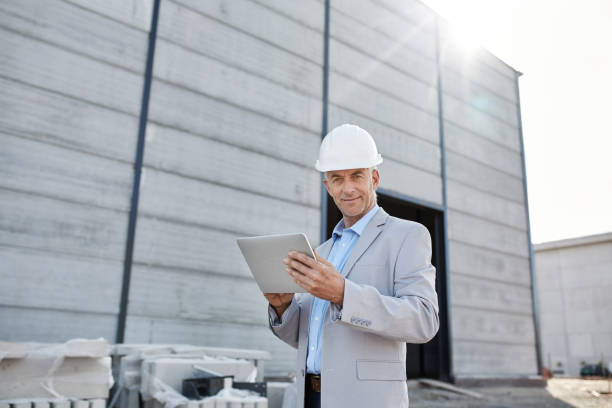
left=0, top=339, right=113, bottom=408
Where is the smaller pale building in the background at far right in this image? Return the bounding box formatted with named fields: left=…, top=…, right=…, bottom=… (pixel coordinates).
left=534, top=233, right=612, bottom=376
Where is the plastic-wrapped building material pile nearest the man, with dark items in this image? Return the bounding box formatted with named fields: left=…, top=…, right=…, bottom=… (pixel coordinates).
left=109, top=344, right=270, bottom=408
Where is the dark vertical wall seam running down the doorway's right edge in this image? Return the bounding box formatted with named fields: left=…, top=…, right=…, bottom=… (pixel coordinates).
left=436, top=15, right=454, bottom=381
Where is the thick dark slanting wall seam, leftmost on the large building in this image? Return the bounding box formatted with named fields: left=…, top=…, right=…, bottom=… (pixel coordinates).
left=116, top=0, right=161, bottom=343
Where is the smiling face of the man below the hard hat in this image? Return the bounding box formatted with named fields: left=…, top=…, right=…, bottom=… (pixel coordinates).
left=323, top=169, right=380, bottom=222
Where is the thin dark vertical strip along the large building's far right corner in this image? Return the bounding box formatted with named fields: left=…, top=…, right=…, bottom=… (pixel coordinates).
left=514, top=72, right=552, bottom=374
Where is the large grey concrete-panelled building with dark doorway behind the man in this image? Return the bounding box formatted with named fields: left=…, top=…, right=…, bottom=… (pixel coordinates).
left=0, top=0, right=538, bottom=379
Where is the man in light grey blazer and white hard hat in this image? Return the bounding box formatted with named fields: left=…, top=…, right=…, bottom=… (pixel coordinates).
left=265, top=124, right=439, bottom=408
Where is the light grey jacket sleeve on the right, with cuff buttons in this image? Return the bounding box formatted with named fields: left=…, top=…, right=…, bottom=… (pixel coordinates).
left=330, top=224, right=440, bottom=343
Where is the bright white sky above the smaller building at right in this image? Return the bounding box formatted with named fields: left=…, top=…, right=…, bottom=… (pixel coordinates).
left=423, top=0, right=612, bottom=243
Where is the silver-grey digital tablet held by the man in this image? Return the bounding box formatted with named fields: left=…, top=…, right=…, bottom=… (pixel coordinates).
left=236, top=233, right=315, bottom=293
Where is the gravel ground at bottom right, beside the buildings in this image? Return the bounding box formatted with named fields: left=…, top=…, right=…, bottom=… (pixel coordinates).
left=409, top=378, right=612, bottom=408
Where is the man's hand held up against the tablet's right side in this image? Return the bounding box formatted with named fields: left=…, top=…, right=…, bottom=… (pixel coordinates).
left=283, top=251, right=344, bottom=307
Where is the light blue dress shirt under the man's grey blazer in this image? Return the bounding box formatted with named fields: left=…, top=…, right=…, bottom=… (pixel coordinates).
left=306, top=204, right=379, bottom=374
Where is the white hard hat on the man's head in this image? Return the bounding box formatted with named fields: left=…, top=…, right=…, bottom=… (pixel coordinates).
left=315, top=123, right=382, bottom=172
